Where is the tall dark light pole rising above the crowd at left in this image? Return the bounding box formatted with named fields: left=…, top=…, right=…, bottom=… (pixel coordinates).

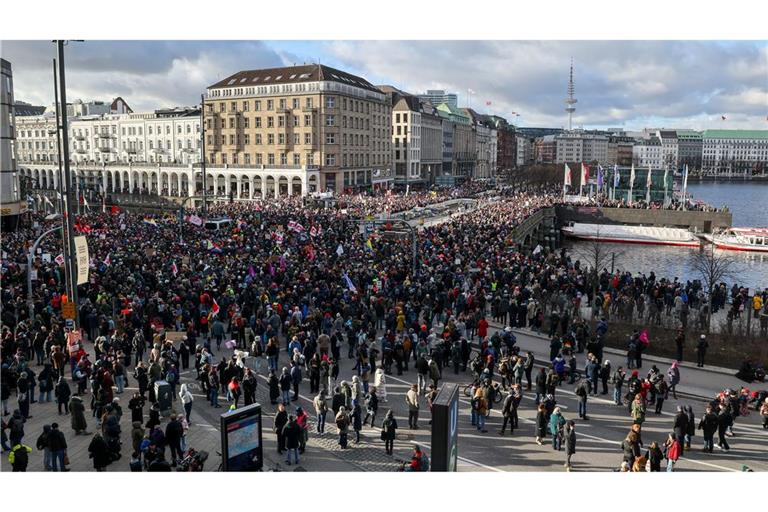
left=56, top=39, right=78, bottom=325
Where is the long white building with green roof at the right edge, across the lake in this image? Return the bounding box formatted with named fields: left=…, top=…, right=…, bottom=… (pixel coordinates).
left=702, top=130, right=768, bottom=174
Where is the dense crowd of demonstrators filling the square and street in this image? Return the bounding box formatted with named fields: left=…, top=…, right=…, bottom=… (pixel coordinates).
left=0, top=185, right=766, bottom=471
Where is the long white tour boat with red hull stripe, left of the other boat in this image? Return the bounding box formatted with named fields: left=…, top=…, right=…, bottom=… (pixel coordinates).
left=562, top=222, right=701, bottom=247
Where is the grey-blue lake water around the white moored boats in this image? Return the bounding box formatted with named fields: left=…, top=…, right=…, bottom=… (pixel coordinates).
left=565, top=182, right=768, bottom=290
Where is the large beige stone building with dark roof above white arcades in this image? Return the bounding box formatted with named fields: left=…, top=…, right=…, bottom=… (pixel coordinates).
left=204, top=64, right=393, bottom=192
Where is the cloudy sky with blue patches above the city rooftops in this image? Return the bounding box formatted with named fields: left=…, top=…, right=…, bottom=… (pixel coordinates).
left=1, top=41, right=768, bottom=130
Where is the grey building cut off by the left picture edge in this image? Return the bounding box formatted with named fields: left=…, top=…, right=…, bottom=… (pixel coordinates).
left=0, top=59, right=27, bottom=229
